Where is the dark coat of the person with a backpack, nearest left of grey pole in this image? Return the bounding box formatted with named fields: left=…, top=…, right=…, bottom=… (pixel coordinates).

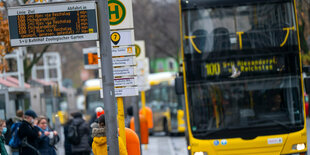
left=71, top=117, right=91, bottom=154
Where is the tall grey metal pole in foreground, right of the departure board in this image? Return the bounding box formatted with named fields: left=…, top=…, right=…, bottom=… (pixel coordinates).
left=97, top=0, right=119, bottom=155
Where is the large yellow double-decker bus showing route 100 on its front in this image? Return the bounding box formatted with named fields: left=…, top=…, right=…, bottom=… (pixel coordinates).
left=180, top=0, right=307, bottom=155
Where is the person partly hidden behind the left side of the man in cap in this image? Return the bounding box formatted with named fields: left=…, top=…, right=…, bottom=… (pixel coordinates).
left=8, top=110, right=24, bottom=155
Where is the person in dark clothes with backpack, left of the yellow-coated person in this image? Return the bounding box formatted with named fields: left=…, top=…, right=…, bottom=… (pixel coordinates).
left=68, top=112, right=91, bottom=155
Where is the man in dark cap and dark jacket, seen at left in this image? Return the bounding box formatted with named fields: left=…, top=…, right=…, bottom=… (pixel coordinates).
left=18, top=110, right=41, bottom=155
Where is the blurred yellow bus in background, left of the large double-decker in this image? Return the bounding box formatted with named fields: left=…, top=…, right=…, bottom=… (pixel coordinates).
left=146, top=72, right=185, bottom=135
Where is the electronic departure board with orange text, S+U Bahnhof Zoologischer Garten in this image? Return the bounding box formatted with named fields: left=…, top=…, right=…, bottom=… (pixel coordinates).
left=8, top=2, right=98, bottom=46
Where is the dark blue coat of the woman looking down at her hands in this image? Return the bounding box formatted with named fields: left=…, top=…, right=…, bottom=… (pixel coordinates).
left=39, top=129, right=56, bottom=155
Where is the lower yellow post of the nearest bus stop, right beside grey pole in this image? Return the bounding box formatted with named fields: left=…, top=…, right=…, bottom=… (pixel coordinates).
left=116, top=97, right=126, bottom=146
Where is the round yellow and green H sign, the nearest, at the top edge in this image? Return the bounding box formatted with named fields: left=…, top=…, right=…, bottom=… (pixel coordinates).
left=108, top=0, right=126, bottom=26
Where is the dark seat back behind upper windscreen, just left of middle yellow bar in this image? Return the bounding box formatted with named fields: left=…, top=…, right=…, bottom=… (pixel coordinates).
left=212, top=27, right=231, bottom=51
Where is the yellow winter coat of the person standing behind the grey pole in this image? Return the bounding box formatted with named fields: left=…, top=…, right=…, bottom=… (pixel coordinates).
left=92, top=128, right=127, bottom=155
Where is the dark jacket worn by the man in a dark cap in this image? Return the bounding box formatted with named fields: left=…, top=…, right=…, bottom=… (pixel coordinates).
left=18, top=120, right=40, bottom=155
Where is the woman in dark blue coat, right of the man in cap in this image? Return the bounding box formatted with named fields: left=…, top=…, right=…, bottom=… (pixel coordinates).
left=37, top=116, right=59, bottom=155
